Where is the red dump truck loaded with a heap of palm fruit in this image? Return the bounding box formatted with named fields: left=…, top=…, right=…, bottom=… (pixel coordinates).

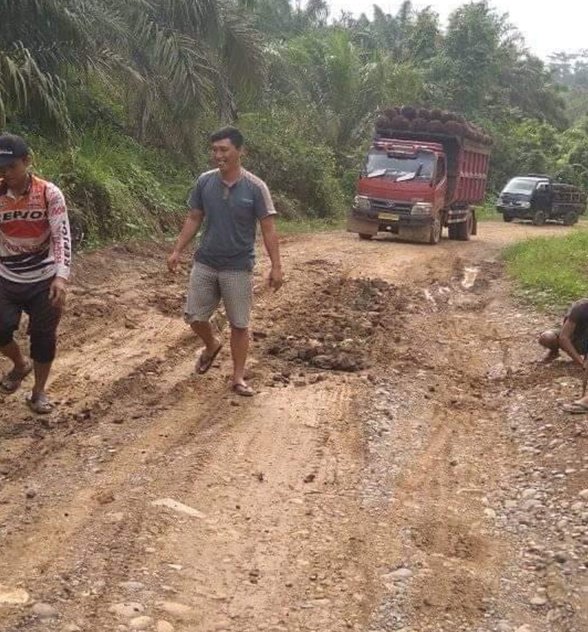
left=347, top=107, right=492, bottom=244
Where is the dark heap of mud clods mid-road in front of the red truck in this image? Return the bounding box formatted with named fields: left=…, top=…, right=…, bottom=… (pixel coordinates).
left=263, top=275, right=423, bottom=372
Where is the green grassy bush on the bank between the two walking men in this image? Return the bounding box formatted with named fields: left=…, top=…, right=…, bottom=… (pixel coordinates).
left=27, top=127, right=193, bottom=244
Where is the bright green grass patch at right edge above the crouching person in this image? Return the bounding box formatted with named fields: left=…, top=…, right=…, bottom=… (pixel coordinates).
left=504, top=228, right=588, bottom=309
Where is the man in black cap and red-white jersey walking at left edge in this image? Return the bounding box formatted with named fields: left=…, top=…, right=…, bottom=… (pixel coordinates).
left=0, top=134, right=71, bottom=414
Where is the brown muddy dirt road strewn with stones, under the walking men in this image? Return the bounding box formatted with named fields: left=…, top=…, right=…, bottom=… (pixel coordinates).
left=0, top=223, right=588, bottom=632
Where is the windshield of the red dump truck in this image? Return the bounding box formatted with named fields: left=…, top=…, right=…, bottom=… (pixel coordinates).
left=363, top=149, right=435, bottom=182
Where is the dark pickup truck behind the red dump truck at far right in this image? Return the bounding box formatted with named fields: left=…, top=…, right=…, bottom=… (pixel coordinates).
left=496, top=174, right=586, bottom=226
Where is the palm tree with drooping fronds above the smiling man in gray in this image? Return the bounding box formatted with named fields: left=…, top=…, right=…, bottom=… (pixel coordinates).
left=127, top=0, right=263, bottom=140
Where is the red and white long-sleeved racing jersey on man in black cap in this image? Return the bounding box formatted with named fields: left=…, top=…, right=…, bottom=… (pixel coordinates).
left=0, top=176, right=71, bottom=283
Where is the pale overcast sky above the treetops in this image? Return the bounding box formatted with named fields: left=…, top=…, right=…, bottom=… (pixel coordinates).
left=328, top=0, right=588, bottom=59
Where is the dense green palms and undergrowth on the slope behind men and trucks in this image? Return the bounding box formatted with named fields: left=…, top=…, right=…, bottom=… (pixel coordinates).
left=0, top=0, right=588, bottom=244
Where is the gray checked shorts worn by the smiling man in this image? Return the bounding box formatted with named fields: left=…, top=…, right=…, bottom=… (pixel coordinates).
left=184, top=261, right=253, bottom=329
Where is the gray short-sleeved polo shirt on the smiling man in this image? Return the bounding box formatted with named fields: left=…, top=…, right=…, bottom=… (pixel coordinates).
left=188, top=169, right=276, bottom=270
